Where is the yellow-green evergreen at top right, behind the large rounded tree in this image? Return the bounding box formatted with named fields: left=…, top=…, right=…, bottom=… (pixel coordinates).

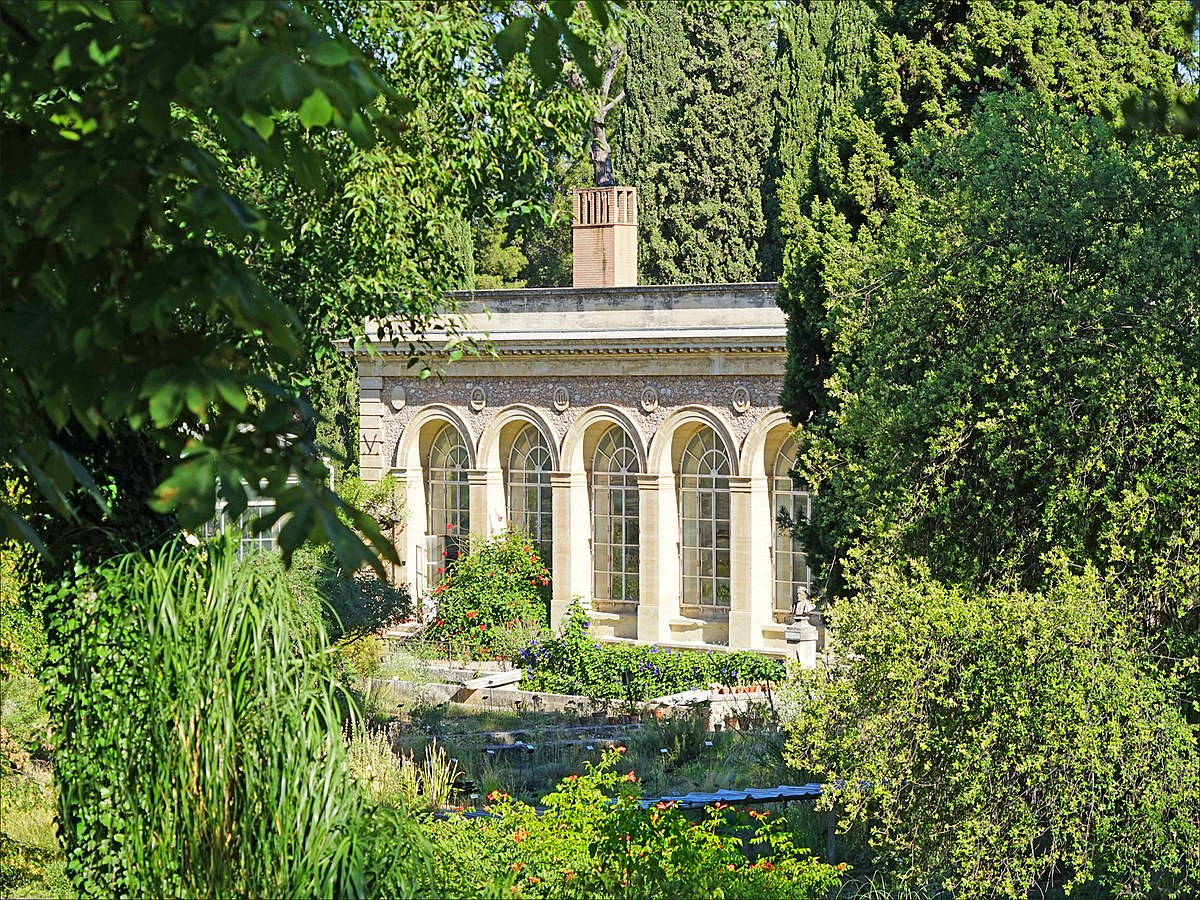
left=773, top=0, right=1196, bottom=421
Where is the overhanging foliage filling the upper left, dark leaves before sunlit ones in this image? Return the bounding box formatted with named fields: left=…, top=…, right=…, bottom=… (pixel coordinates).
left=0, top=1, right=607, bottom=569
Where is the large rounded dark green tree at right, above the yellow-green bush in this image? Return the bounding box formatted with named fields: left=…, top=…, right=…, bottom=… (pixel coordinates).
left=802, top=97, right=1200, bottom=629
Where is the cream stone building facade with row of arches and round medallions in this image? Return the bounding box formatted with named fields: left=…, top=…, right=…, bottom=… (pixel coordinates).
left=359, top=283, right=811, bottom=655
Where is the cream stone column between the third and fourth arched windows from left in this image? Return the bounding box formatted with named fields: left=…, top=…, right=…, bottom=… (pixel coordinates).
left=637, top=473, right=679, bottom=643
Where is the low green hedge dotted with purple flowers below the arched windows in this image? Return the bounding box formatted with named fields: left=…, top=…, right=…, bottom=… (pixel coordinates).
left=515, top=604, right=786, bottom=701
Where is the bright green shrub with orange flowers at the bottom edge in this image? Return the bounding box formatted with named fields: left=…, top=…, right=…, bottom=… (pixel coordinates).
left=428, top=748, right=838, bottom=900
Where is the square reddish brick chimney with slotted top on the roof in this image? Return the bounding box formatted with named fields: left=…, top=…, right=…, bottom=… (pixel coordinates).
left=571, top=187, right=637, bottom=288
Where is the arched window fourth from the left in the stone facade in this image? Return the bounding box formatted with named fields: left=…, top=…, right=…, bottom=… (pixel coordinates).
left=679, top=428, right=730, bottom=608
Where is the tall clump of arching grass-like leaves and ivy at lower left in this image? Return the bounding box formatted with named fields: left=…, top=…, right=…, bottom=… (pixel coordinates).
left=50, top=538, right=429, bottom=896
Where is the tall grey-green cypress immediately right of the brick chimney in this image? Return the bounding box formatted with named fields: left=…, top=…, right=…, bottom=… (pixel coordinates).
left=613, top=4, right=774, bottom=284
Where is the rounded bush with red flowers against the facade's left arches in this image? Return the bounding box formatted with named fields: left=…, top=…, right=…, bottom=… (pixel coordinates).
left=426, top=532, right=550, bottom=659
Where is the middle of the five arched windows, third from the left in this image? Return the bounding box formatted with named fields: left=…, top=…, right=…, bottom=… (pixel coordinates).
left=592, top=426, right=640, bottom=602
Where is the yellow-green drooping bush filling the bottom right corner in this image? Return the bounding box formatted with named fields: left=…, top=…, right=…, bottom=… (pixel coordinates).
left=787, top=556, right=1200, bottom=898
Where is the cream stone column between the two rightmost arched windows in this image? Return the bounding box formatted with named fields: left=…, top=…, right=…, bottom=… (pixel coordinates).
left=730, top=475, right=774, bottom=649
